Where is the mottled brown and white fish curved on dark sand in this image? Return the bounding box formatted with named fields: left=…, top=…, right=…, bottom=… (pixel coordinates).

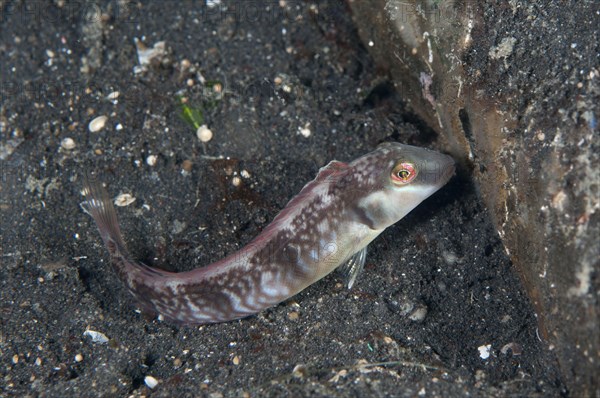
left=82, top=142, right=455, bottom=325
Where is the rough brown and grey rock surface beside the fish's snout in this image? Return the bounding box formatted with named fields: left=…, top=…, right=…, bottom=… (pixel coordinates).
left=349, top=0, right=600, bottom=396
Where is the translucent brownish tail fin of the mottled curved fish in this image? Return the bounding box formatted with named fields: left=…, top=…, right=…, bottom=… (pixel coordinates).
left=82, top=175, right=127, bottom=255
